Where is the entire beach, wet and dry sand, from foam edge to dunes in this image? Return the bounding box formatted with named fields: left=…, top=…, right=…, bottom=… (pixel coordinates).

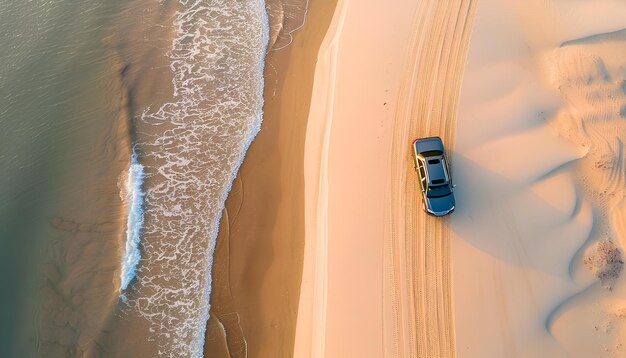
left=205, top=0, right=626, bottom=357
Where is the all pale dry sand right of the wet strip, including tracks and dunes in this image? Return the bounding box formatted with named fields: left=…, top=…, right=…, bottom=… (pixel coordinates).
left=294, top=0, right=626, bottom=357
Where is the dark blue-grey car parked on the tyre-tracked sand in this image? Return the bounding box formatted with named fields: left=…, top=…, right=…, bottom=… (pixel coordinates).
left=412, top=137, right=456, bottom=216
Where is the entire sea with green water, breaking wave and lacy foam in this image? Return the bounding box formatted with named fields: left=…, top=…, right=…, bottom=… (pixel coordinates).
left=0, top=0, right=272, bottom=357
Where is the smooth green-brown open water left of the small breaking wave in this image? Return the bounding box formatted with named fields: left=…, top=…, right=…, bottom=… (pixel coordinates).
left=0, top=1, right=128, bottom=357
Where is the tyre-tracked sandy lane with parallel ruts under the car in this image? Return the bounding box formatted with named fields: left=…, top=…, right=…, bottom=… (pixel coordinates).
left=383, top=0, right=477, bottom=357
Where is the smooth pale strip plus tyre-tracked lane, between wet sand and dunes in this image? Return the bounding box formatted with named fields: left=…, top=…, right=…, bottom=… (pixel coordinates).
left=295, top=1, right=473, bottom=357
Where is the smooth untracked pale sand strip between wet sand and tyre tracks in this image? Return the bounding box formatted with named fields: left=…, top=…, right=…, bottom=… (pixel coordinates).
left=294, top=0, right=416, bottom=357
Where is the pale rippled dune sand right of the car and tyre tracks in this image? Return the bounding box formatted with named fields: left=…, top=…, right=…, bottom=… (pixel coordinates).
left=452, top=0, right=626, bottom=357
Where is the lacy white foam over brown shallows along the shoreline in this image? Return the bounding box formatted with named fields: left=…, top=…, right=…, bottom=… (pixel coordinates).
left=127, top=0, right=269, bottom=357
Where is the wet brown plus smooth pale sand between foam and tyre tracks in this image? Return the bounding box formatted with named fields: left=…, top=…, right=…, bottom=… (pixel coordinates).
left=205, top=1, right=446, bottom=357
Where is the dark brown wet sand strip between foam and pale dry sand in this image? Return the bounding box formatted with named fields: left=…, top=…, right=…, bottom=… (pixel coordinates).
left=205, top=0, right=336, bottom=357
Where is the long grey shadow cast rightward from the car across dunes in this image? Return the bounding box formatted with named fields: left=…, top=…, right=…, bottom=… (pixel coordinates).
left=452, top=148, right=593, bottom=275
